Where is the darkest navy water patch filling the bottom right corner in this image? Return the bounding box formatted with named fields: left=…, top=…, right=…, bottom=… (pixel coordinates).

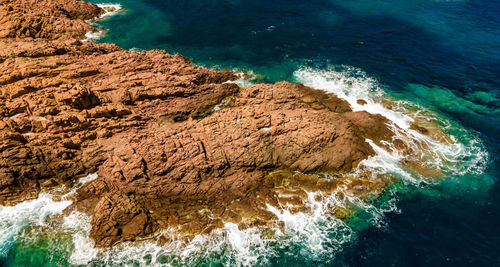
left=334, top=177, right=500, bottom=266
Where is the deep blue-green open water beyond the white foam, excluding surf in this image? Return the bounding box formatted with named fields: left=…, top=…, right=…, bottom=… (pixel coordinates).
left=2, top=0, right=500, bottom=266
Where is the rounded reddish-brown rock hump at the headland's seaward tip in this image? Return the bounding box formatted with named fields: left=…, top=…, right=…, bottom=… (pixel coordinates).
left=71, top=82, right=392, bottom=246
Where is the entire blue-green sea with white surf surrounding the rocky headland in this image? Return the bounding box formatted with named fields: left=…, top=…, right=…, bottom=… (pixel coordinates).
left=0, top=0, right=500, bottom=267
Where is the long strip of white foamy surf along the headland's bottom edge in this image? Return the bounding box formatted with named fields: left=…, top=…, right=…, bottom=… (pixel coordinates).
left=58, top=187, right=379, bottom=266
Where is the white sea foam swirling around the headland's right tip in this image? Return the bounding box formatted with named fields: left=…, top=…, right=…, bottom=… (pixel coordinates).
left=294, top=66, right=488, bottom=183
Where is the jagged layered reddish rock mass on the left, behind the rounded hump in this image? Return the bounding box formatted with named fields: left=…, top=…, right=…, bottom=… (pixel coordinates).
left=0, top=1, right=238, bottom=207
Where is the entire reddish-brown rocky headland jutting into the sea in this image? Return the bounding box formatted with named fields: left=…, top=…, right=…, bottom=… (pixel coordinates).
left=0, top=0, right=442, bottom=247
